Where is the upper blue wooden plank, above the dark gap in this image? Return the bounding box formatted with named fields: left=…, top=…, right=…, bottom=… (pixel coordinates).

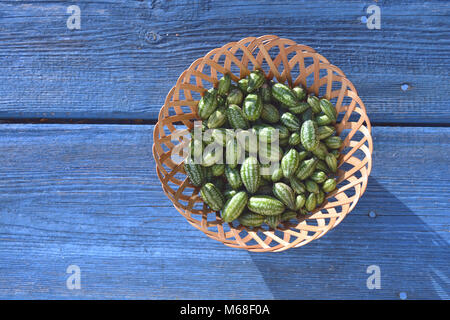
left=0, top=0, right=450, bottom=124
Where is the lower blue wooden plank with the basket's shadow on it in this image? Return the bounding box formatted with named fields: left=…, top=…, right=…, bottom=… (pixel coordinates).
left=0, top=124, right=450, bottom=299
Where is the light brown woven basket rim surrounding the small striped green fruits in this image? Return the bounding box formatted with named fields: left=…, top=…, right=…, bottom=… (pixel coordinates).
left=153, top=35, right=372, bottom=252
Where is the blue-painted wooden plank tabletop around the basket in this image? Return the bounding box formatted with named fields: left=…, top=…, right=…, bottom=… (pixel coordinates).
left=0, top=0, right=450, bottom=299
